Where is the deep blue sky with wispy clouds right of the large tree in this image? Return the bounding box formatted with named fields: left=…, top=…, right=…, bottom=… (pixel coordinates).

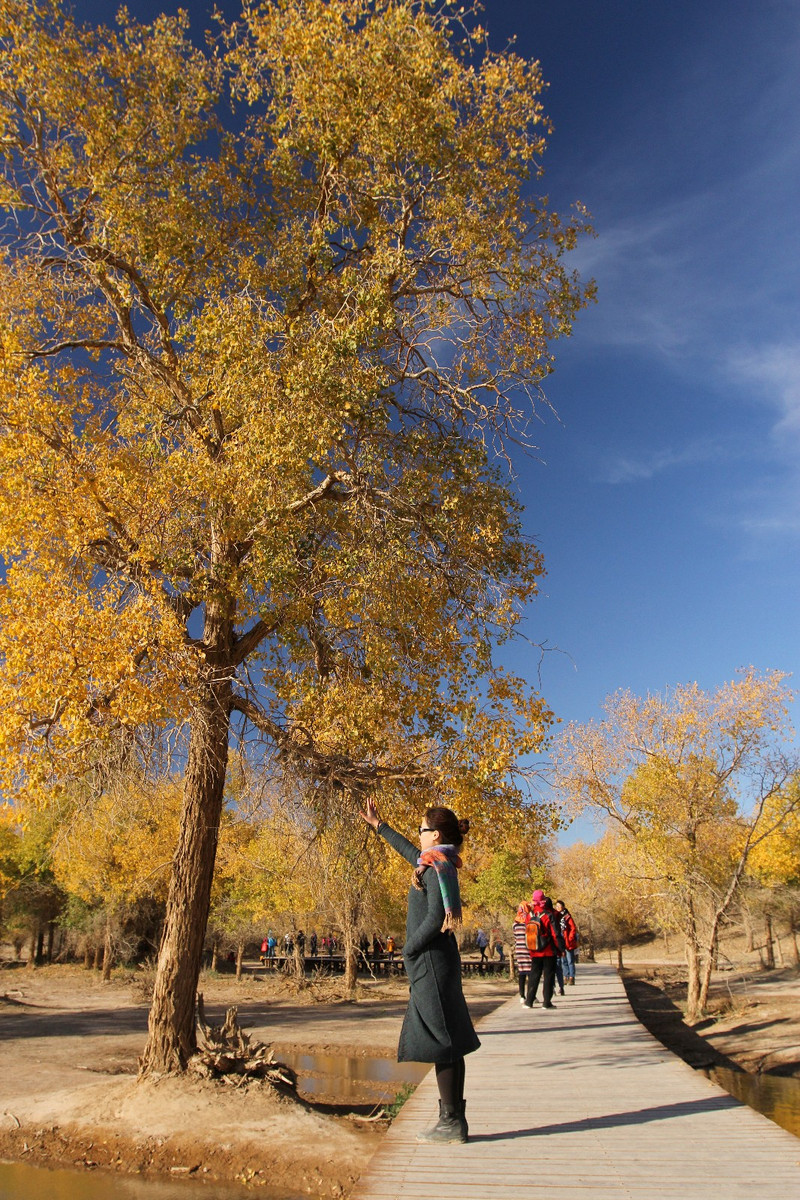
left=67, top=0, right=800, bottom=840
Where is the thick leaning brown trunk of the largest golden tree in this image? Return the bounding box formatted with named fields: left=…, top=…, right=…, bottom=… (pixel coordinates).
left=139, top=676, right=233, bottom=1075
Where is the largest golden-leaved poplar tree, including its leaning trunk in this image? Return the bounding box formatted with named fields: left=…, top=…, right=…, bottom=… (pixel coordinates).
left=0, top=0, right=587, bottom=1073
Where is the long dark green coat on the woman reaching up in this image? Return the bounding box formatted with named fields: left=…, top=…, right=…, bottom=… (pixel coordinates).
left=378, top=821, right=481, bottom=1062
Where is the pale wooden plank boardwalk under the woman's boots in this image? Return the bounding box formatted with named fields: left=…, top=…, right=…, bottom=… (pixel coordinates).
left=353, top=964, right=800, bottom=1200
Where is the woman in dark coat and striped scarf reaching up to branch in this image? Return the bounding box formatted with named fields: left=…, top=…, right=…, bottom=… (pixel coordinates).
left=361, top=800, right=481, bottom=1142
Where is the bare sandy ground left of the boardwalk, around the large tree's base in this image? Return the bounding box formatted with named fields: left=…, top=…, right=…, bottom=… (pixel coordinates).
left=0, top=966, right=512, bottom=1200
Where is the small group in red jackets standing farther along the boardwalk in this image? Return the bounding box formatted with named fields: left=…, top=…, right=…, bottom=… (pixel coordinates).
left=513, top=888, right=578, bottom=1008
